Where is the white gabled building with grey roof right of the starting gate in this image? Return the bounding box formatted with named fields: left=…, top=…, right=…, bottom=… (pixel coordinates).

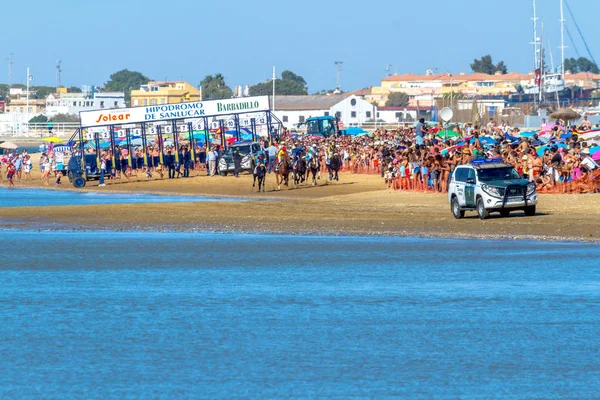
left=269, top=94, right=377, bottom=129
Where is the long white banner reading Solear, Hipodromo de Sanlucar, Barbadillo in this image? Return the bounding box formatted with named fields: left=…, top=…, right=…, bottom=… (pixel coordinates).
left=79, top=96, right=269, bottom=128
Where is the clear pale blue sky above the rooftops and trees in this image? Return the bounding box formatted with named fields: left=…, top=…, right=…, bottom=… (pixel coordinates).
left=0, top=0, right=600, bottom=92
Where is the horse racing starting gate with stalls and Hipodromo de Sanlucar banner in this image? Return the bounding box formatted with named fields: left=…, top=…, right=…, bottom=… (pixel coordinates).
left=70, top=96, right=283, bottom=178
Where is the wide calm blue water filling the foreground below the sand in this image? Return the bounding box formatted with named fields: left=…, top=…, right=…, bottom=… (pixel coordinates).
left=0, top=231, right=600, bottom=399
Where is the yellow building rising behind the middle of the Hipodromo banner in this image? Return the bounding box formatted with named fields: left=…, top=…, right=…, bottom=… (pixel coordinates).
left=131, top=81, right=201, bottom=107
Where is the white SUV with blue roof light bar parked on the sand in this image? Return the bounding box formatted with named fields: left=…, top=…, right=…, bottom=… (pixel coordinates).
left=448, top=159, right=538, bottom=219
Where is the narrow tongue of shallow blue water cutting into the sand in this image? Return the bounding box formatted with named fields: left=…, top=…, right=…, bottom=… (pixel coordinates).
left=0, top=187, right=241, bottom=207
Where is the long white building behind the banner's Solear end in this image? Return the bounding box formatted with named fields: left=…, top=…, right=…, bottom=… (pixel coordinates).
left=44, top=92, right=126, bottom=118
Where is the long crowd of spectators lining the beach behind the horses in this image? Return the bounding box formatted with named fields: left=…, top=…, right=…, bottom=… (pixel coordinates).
left=0, top=118, right=600, bottom=192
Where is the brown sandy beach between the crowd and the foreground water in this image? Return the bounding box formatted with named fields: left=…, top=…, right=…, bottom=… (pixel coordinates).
left=0, top=165, right=600, bottom=241
